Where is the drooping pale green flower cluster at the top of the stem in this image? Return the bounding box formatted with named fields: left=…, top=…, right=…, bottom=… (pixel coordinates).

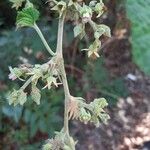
left=47, top=0, right=111, bottom=57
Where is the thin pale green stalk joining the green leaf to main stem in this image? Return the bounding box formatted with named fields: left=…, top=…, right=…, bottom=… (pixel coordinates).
left=33, top=23, right=56, bottom=56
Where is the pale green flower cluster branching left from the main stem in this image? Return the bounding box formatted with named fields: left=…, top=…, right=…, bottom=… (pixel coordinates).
left=8, top=57, right=61, bottom=106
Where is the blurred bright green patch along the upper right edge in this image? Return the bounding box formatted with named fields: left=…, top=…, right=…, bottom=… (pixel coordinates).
left=127, top=0, right=150, bottom=75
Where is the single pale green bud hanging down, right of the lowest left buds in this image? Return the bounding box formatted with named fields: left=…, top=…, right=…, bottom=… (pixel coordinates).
left=31, top=84, right=41, bottom=105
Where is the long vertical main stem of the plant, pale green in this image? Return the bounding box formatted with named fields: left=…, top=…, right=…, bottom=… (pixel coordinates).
left=56, top=13, right=70, bottom=135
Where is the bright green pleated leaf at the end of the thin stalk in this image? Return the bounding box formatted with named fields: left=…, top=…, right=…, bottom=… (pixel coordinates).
left=16, top=7, right=39, bottom=27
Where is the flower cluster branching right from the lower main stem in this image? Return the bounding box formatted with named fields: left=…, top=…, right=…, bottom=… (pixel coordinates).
left=69, top=97, right=110, bottom=127
